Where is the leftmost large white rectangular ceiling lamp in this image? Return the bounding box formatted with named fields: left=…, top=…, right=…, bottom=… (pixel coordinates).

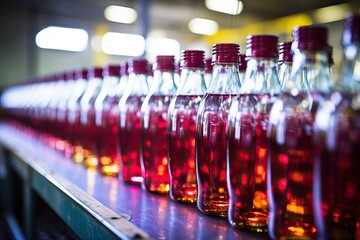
left=35, top=26, right=88, bottom=52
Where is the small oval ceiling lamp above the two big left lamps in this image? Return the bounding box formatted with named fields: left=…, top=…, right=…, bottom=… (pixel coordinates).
left=104, top=5, right=137, bottom=24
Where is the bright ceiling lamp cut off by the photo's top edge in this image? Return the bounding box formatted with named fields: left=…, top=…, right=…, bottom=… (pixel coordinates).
left=205, top=0, right=244, bottom=15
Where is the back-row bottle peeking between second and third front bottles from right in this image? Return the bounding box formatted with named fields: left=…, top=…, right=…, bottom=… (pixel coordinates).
left=279, top=41, right=292, bottom=88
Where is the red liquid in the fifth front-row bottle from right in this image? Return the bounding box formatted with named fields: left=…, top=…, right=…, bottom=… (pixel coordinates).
left=167, top=96, right=202, bottom=203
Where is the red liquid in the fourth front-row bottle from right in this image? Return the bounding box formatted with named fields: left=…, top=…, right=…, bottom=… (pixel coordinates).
left=196, top=94, right=235, bottom=217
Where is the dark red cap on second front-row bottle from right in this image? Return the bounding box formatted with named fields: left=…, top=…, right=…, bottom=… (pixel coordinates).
left=291, top=25, right=328, bottom=51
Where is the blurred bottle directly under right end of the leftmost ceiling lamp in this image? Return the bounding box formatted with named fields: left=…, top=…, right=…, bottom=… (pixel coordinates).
left=65, top=69, right=88, bottom=162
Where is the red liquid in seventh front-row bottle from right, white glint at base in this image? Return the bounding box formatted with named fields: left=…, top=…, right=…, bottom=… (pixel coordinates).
left=119, top=96, right=145, bottom=183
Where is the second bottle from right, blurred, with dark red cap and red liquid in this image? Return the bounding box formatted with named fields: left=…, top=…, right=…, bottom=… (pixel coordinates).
left=267, top=25, right=331, bottom=239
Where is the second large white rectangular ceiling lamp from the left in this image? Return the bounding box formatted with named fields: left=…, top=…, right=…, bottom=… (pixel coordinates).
left=101, top=32, right=145, bottom=57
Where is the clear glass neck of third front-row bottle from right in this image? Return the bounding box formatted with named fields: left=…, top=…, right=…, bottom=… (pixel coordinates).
left=241, top=57, right=281, bottom=95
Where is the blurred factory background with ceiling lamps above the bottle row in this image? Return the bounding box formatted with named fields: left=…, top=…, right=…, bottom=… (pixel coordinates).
left=0, top=0, right=360, bottom=88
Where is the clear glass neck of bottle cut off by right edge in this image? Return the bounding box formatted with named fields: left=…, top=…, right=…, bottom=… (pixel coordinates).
left=336, top=43, right=360, bottom=93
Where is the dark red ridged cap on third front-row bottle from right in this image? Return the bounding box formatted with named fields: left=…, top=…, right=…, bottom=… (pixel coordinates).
left=246, top=35, right=279, bottom=58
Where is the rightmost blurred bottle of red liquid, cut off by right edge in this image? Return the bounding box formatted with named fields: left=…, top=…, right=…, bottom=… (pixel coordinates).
left=314, top=15, right=360, bottom=239
